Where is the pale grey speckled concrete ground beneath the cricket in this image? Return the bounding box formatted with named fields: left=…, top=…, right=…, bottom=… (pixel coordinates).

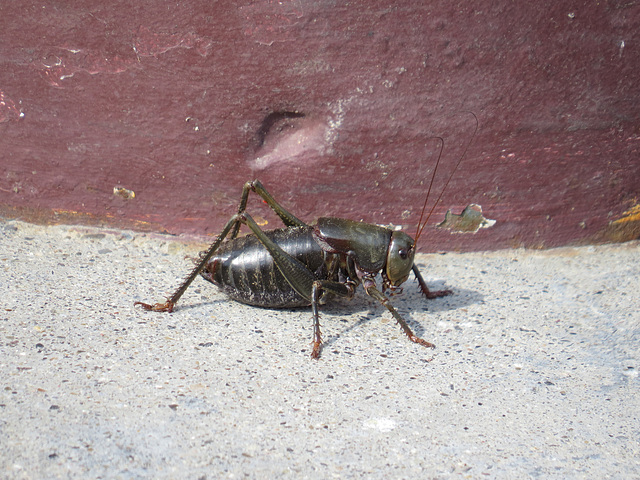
left=0, top=221, right=640, bottom=479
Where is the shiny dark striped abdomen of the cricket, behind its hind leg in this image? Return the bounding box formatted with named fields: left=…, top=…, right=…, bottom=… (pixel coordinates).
left=202, top=227, right=327, bottom=308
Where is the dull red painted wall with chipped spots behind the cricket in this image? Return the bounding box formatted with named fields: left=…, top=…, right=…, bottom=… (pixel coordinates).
left=0, top=0, right=640, bottom=251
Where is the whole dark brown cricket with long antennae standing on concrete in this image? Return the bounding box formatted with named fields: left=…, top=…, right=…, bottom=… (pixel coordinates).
left=135, top=115, right=477, bottom=358
